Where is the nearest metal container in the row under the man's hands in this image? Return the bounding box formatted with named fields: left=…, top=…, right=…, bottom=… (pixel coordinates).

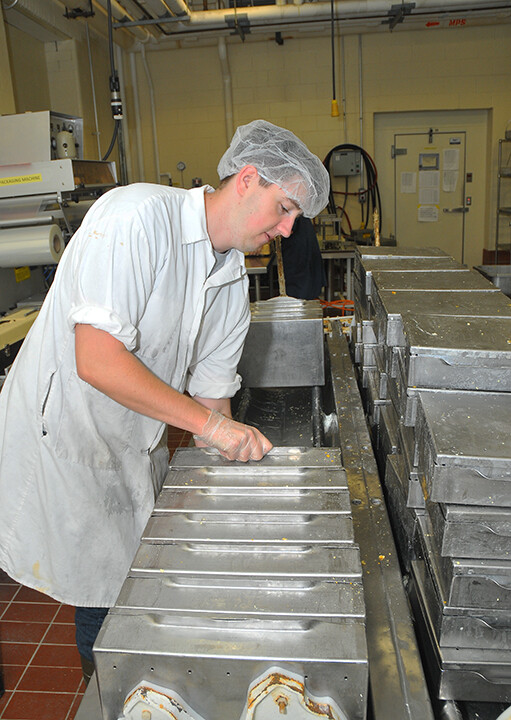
left=95, top=612, right=368, bottom=720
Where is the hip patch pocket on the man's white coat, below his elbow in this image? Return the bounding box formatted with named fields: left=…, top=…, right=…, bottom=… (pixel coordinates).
left=50, top=372, right=126, bottom=470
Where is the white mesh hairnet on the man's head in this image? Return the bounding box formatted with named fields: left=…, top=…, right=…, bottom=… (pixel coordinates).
left=217, top=120, right=330, bottom=217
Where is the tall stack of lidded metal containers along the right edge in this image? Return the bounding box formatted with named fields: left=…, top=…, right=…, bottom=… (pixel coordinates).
left=351, top=247, right=511, bottom=702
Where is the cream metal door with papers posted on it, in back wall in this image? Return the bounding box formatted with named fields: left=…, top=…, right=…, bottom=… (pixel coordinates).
left=392, top=128, right=470, bottom=262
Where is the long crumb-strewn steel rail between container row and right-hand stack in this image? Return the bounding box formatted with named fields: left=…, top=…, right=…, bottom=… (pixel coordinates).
left=328, top=323, right=434, bottom=720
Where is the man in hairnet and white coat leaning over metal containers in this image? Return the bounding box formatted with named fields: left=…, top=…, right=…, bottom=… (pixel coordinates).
left=0, top=121, right=329, bottom=674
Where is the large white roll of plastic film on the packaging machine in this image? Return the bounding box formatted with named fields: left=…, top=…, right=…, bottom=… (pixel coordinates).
left=0, top=225, right=64, bottom=267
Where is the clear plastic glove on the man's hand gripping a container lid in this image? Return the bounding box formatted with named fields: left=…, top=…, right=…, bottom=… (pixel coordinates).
left=193, top=410, right=273, bottom=462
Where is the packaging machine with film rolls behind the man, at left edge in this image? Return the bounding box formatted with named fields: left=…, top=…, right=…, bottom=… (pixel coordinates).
left=0, top=111, right=117, bottom=375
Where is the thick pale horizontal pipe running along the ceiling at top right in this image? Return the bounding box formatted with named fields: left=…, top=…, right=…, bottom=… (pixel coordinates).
left=119, top=0, right=511, bottom=36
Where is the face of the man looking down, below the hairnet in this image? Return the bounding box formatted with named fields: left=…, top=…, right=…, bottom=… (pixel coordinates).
left=233, top=176, right=302, bottom=252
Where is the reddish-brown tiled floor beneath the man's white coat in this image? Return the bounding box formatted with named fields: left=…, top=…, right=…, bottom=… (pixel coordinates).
left=0, top=427, right=191, bottom=720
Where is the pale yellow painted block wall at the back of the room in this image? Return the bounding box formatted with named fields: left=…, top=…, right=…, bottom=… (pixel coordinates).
left=0, top=7, right=511, bottom=256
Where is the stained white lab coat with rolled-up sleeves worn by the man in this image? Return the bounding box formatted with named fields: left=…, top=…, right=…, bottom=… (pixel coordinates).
left=0, top=184, right=250, bottom=607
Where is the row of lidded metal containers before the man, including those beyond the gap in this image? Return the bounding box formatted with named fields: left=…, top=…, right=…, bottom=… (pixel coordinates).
left=94, top=298, right=368, bottom=720
